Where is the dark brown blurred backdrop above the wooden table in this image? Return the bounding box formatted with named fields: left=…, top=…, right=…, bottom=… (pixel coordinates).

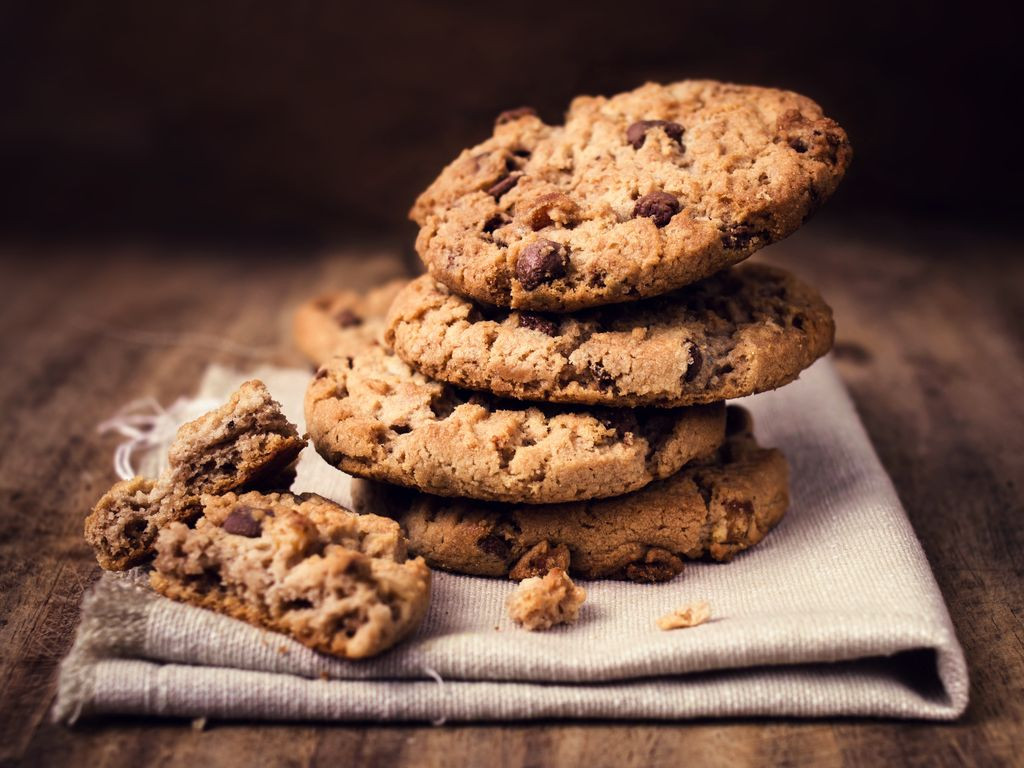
left=0, top=0, right=1022, bottom=243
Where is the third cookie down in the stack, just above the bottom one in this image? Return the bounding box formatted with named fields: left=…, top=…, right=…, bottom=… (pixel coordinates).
left=305, top=347, right=725, bottom=504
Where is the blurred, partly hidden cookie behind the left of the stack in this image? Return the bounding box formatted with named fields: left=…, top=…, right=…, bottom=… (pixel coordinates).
left=292, top=280, right=409, bottom=366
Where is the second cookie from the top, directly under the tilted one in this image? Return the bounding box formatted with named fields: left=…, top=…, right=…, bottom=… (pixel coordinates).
left=385, top=264, right=835, bottom=407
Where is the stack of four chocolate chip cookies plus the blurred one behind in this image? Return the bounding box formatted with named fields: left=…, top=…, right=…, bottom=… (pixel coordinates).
left=295, top=81, right=851, bottom=582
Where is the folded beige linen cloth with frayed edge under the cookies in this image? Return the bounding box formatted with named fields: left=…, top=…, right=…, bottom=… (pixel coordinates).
left=54, top=358, right=968, bottom=722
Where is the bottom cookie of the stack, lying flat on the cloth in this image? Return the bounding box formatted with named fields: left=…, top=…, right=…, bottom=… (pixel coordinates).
left=362, top=406, right=788, bottom=582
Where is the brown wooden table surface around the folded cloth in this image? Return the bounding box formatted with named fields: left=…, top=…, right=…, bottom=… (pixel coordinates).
left=0, top=222, right=1024, bottom=766
